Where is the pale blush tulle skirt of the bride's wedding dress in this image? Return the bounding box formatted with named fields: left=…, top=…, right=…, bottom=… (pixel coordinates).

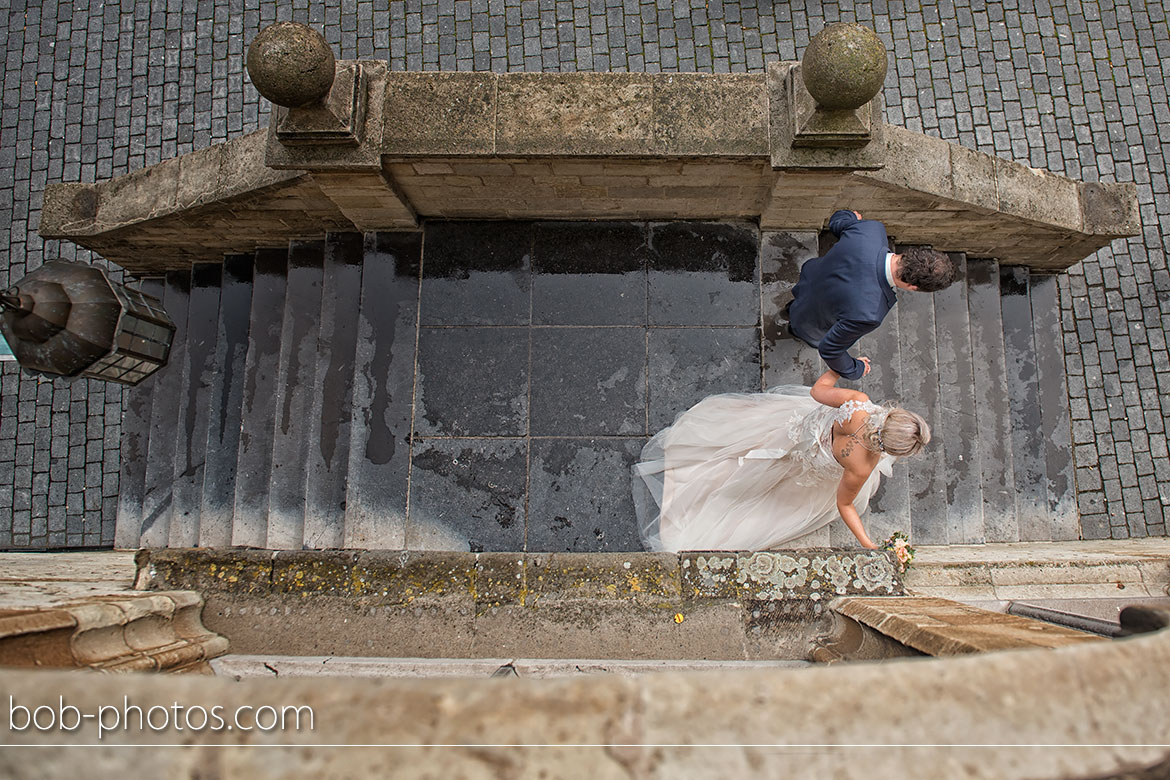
left=633, top=386, right=893, bottom=552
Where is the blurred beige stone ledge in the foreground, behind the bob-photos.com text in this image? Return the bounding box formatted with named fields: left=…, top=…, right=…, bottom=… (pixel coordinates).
left=0, top=630, right=1170, bottom=780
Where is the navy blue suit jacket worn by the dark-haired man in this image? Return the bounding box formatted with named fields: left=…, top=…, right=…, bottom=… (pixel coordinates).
left=789, top=210, right=897, bottom=379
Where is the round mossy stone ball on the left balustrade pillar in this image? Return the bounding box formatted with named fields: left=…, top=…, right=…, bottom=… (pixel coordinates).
left=248, top=22, right=337, bottom=109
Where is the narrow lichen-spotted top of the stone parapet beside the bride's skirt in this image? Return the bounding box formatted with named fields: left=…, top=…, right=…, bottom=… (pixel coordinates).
left=137, top=547, right=904, bottom=609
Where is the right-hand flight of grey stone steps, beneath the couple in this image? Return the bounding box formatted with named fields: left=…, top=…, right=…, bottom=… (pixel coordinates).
left=761, top=234, right=1071, bottom=545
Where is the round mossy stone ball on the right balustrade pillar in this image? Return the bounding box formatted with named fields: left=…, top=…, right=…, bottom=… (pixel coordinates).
left=800, top=22, right=887, bottom=111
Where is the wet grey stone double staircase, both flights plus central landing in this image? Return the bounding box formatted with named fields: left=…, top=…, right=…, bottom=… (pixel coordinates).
left=116, top=222, right=1081, bottom=552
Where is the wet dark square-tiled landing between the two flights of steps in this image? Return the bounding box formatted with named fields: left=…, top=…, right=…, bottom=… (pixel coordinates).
left=406, top=222, right=762, bottom=552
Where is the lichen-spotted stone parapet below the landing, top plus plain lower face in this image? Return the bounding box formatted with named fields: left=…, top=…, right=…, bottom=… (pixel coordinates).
left=138, top=548, right=902, bottom=660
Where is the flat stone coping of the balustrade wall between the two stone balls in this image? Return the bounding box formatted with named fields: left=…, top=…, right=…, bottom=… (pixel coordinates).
left=383, top=73, right=769, bottom=158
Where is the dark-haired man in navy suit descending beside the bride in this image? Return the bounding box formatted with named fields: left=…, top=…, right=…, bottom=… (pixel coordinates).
left=789, top=209, right=955, bottom=379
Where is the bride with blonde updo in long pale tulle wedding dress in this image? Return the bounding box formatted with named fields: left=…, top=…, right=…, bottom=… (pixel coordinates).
left=633, top=370, right=930, bottom=552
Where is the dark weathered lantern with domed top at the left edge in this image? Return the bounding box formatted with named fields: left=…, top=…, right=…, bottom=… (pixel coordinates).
left=0, top=261, right=174, bottom=385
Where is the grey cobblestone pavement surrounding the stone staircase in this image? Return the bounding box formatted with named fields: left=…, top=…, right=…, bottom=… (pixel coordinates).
left=0, top=0, right=1170, bottom=548
